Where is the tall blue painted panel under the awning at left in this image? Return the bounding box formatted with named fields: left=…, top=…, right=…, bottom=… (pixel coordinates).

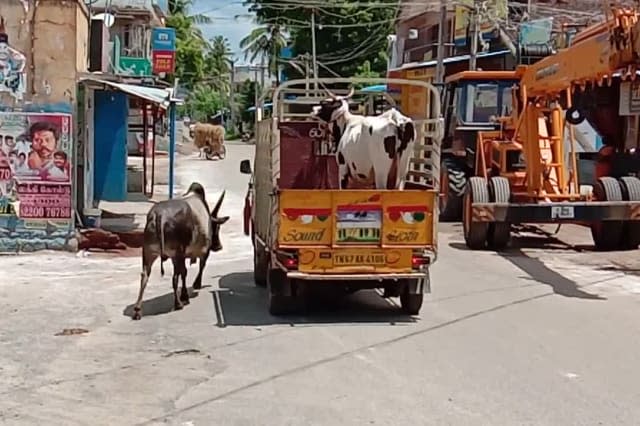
left=93, top=90, right=129, bottom=201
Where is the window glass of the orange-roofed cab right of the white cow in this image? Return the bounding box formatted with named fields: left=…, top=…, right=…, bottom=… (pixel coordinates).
left=456, top=82, right=513, bottom=124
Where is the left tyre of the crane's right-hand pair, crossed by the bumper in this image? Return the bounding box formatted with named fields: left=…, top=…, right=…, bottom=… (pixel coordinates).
left=591, top=176, right=624, bottom=251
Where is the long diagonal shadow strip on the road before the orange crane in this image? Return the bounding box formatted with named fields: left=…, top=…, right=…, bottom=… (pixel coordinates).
left=449, top=238, right=607, bottom=300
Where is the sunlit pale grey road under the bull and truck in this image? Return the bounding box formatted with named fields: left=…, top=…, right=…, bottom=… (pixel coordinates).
left=0, top=143, right=640, bottom=426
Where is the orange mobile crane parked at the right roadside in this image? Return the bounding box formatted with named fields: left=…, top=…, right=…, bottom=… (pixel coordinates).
left=462, top=6, right=640, bottom=250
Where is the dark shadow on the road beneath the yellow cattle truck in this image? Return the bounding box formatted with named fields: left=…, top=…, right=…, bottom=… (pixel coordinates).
left=220, top=272, right=416, bottom=326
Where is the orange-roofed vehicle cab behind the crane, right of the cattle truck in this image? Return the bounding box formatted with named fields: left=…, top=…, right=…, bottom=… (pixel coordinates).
left=442, top=71, right=519, bottom=151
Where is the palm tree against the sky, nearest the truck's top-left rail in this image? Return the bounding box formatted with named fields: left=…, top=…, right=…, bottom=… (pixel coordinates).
left=240, top=24, right=287, bottom=84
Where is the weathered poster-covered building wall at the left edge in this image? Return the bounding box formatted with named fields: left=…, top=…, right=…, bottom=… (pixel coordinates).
left=0, top=0, right=89, bottom=252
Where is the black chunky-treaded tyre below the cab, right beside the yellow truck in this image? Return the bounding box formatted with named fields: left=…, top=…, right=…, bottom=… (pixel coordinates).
left=439, top=159, right=467, bottom=222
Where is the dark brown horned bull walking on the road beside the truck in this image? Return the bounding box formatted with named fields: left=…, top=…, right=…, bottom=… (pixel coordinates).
left=133, top=183, right=229, bottom=320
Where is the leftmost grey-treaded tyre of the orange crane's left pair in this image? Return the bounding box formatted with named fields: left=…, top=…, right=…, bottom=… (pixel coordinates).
left=462, top=176, right=489, bottom=250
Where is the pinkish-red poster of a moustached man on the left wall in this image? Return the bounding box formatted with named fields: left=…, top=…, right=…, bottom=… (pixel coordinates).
left=0, top=112, right=72, bottom=221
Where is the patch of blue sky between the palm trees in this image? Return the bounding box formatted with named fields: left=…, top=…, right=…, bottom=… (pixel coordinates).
left=191, top=0, right=256, bottom=64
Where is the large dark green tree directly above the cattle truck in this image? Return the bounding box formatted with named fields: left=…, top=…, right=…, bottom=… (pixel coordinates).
left=245, top=0, right=398, bottom=78
